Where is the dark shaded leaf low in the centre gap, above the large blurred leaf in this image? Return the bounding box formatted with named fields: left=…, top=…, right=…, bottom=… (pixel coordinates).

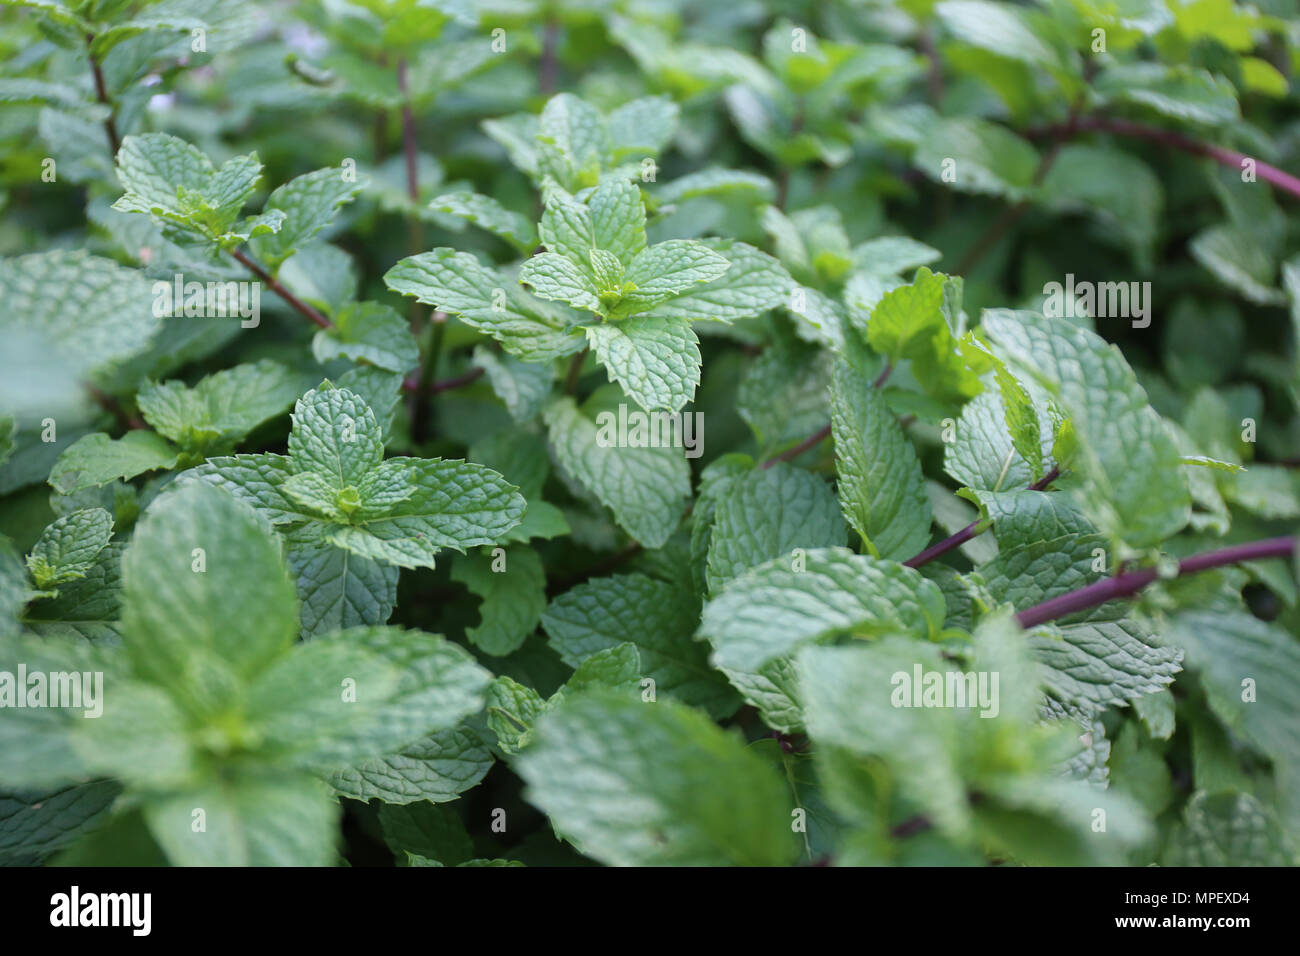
left=542, top=574, right=735, bottom=715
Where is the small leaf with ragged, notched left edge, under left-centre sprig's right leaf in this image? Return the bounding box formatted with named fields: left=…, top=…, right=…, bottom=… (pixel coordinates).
left=451, top=548, right=546, bottom=657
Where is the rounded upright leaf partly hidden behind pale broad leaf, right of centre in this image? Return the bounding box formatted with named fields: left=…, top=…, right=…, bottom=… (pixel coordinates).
left=707, top=462, right=848, bottom=592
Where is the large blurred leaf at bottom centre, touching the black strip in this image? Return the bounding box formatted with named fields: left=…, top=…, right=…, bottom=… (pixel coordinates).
left=517, top=692, right=796, bottom=866
